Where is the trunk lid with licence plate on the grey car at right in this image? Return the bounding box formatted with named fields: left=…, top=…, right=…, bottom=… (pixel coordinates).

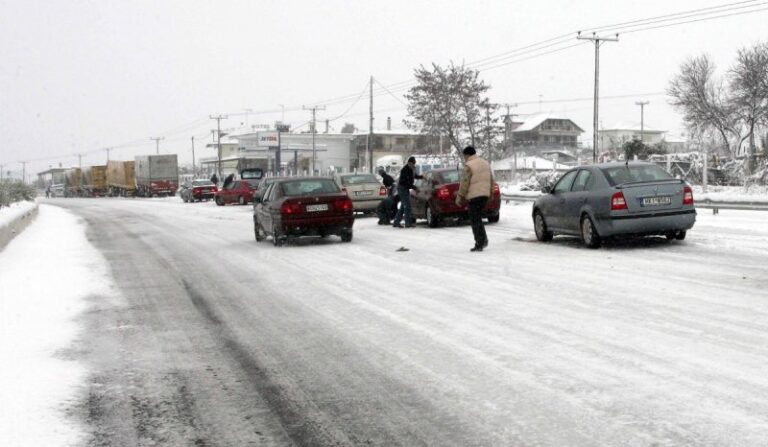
left=617, top=180, right=685, bottom=213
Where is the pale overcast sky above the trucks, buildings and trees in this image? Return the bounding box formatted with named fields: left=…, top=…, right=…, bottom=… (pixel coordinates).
left=0, top=0, right=768, bottom=178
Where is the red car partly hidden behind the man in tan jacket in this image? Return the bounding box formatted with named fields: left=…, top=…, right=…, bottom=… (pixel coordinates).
left=411, top=168, right=501, bottom=228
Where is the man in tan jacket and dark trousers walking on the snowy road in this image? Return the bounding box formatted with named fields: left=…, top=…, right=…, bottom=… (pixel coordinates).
left=456, top=146, right=493, bottom=251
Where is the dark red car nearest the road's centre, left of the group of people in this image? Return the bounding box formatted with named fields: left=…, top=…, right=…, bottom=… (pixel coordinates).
left=253, top=177, right=355, bottom=246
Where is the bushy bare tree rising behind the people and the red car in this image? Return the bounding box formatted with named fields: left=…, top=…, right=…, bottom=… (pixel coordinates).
left=405, top=63, right=497, bottom=152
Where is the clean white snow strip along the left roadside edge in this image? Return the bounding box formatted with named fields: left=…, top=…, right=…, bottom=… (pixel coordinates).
left=0, top=202, right=118, bottom=446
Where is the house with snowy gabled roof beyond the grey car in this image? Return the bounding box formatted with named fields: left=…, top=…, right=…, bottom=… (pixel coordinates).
left=510, top=113, right=584, bottom=155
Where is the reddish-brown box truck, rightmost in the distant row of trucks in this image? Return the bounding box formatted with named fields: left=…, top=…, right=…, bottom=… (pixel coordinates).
left=135, top=154, right=179, bottom=197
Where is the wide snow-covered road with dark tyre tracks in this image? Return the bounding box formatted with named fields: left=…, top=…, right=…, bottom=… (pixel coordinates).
left=6, top=199, right=768, bottom=446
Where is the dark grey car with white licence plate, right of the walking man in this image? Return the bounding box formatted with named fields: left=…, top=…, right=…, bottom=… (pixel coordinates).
left=532, top=162, right=696, bottom=248
